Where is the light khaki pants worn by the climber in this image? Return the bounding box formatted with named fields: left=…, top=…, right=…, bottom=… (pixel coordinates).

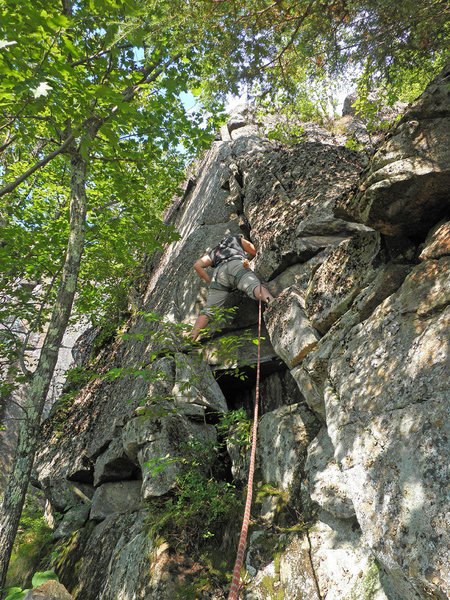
left=201, top=259, right=261, bottom=315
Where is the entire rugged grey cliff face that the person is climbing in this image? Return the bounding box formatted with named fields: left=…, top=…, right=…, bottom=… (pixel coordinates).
left=29, top=61, right=450, bottom=600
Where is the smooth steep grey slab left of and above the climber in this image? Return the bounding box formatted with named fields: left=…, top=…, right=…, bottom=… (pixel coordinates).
left=143, top=136, right=273, bottom=321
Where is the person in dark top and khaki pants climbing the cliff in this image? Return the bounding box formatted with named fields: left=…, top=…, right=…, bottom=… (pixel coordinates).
left=190, top=235, right=273, bottom=341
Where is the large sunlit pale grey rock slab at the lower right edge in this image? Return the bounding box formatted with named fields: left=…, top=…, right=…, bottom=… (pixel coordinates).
left=325, top=257, right=450, bottom=600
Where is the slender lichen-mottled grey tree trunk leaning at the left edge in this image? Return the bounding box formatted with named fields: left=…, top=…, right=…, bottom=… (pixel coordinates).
left=0, top=149, right=86, bottom=590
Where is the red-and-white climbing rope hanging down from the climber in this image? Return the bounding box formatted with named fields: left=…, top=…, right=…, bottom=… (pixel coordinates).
left=228, top=298, right=262, bottom=600
